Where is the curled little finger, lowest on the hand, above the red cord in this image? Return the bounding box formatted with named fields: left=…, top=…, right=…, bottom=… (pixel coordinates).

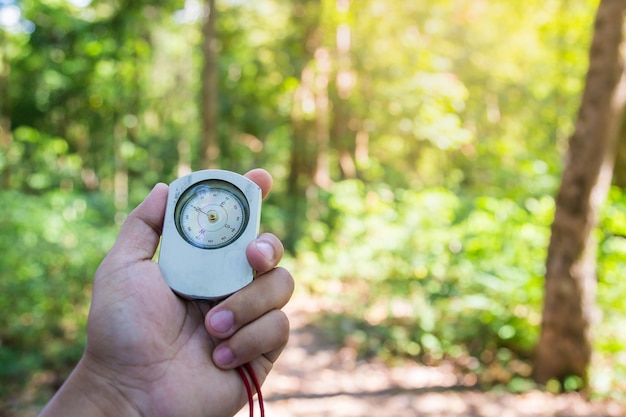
left=213, top=310, right=289, bottom=369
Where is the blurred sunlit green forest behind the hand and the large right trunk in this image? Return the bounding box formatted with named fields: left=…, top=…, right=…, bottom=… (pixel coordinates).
left=0, top=0, right=626, bottom=411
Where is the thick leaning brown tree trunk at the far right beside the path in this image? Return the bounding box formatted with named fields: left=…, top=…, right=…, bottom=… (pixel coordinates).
left=535, top=0, right=626, bottom=386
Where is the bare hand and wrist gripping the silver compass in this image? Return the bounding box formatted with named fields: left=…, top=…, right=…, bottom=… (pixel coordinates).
left=40, top=169, right=294, bottom=417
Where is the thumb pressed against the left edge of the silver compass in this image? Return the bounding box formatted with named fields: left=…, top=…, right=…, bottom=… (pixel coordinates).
left=109, top=183, right=168, bottom=261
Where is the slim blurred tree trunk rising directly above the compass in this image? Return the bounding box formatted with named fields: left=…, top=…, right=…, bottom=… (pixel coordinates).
left=200, top=0, right=220, bottom=169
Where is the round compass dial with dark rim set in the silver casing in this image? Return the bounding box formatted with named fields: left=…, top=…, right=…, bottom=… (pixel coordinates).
left=174, top=180, right=249, bottom=249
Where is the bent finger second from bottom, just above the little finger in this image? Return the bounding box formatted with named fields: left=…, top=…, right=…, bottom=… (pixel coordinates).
left=204, top=268, right=294, bottom=339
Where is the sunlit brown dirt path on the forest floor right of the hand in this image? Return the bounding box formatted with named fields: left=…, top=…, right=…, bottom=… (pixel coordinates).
left=237, top=299, right=626, bottom=417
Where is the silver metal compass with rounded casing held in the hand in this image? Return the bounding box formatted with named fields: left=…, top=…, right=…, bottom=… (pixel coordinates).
left=159, top=169, right=262, bottom=300
